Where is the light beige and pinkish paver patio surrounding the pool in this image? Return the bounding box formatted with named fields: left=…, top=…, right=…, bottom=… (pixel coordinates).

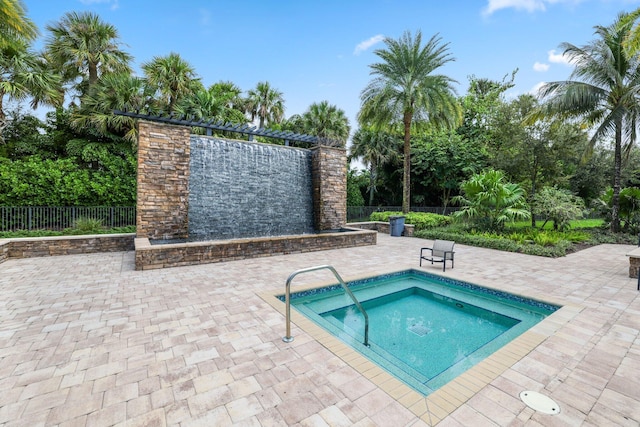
left=0, top=235, right=640, bottom=427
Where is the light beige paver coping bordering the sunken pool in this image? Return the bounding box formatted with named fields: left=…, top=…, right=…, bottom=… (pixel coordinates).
left=257, top=268, right=583, bottom=425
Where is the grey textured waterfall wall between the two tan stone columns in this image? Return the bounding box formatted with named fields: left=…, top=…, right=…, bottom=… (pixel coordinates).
left=189, top=135, right=314, bottom=240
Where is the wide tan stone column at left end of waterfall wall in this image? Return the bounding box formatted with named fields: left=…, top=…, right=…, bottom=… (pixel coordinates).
left=136, top=120, right=190, bottom=239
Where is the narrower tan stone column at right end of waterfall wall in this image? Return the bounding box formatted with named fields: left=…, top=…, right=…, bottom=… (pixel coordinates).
left=311, top=145, right=347, bottom=231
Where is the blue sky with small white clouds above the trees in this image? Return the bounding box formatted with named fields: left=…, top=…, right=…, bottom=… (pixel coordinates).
left=24, top=0, right=640, bottom=134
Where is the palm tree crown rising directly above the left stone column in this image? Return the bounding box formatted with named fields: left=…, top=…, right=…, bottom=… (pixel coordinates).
left=142, top=52, right=202, bottom=113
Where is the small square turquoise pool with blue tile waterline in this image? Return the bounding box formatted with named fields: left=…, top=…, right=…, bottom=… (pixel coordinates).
left=279, top=270, right=559, bottom=396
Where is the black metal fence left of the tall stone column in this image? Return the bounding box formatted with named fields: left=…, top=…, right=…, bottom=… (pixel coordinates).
left=0, top=206, right=136, bottom=231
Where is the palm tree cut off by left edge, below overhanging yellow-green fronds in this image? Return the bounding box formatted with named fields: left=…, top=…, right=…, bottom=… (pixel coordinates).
left=0, top=38, right=62, bottom=142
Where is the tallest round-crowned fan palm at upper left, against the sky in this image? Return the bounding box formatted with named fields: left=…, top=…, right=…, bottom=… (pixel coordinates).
left=45, top=12, right=132, bottom=100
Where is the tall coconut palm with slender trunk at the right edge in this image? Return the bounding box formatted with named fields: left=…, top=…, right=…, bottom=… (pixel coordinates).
left=539, top=13, right=640, bottom=232
